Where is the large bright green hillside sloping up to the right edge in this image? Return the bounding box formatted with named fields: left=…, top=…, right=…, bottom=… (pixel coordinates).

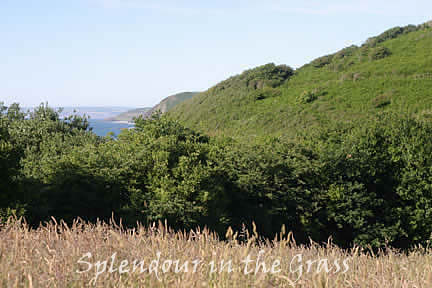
left=169, top=22, right=432, bottom=138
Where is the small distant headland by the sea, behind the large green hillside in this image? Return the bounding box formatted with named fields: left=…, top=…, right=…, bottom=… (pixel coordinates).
left=108, top=92, right=198, bottom=121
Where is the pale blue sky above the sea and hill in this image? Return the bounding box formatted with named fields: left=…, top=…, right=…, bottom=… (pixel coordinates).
left=0, top=0, right=432, bottom=107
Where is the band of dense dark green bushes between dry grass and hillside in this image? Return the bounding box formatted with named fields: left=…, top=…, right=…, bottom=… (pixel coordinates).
left=0, top=102, right=432, bottom=247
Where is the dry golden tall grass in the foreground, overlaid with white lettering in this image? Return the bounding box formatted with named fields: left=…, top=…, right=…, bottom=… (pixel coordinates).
left=0, top=220, right=432, bottom=288
